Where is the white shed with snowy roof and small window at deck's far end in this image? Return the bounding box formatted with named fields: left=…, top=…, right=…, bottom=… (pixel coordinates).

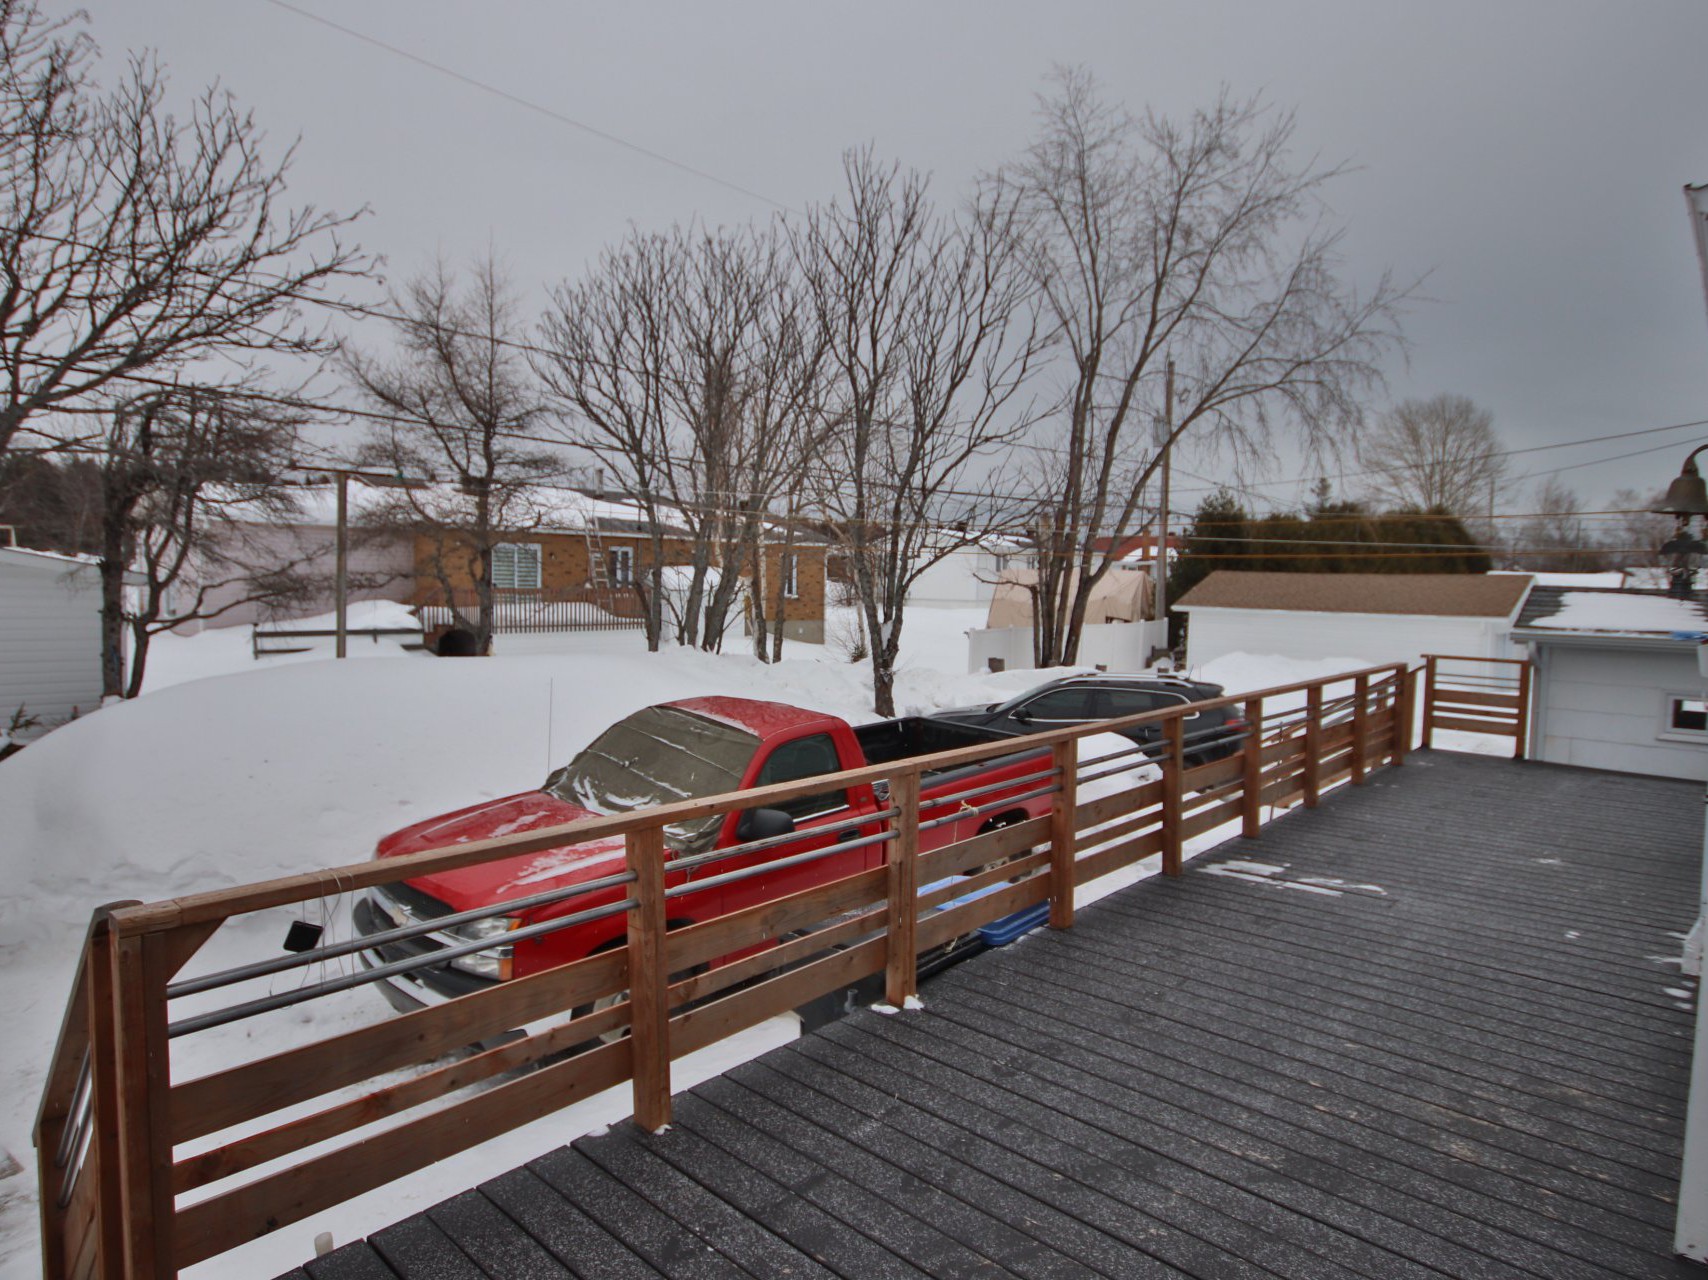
left=1513, top=586, right=1708, bottom=781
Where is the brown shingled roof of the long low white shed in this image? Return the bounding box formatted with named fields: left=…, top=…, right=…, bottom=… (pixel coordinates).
left=1177, top=569, right=1530, bottom=617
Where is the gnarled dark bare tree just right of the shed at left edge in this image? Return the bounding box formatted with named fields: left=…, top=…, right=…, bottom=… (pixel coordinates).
left=99, top=388, right=311, bottom=697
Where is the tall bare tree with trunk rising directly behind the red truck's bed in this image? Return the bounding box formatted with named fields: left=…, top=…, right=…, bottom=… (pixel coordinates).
left=794, top=150, right=1042, bottom=716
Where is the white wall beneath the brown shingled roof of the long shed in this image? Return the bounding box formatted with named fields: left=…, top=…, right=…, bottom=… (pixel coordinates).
left=1185, top=605, right=1517, bottom=666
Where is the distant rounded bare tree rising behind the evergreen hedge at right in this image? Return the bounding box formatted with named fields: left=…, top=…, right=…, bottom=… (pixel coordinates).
left=1358, top=393, right=1506, bottom=516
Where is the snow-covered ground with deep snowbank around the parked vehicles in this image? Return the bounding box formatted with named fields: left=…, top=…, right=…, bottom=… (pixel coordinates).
left=0, top=608, right=1441, bottom=1280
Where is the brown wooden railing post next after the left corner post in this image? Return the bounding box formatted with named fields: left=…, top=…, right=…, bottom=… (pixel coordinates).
left=623, top=827, right=670, bottom=1133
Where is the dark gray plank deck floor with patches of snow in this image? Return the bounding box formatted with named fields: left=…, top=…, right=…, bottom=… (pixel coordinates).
left=292, top=752, right=1708, bottom=1280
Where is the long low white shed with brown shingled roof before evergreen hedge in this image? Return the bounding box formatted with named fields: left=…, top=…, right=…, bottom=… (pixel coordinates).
left=1175, top=569, right=1530, bottom=666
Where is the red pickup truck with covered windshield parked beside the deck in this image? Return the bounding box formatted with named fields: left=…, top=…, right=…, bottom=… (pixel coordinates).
left=355, top=697, right=1050, bottom=1012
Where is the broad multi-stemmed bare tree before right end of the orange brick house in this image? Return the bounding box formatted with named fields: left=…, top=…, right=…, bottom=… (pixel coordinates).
left=540, top=218, right=820, bottom=649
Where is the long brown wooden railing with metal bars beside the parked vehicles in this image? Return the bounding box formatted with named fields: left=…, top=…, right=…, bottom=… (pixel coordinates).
left=36, top=666, right=1414, bottom=1280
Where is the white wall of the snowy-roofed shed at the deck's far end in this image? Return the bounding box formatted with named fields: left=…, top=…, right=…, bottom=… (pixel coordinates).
left=1532, top=641, right=1708, bottom=781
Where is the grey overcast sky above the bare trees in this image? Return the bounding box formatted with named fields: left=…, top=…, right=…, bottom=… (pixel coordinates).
left=73, top=0, right=1708, bottom=509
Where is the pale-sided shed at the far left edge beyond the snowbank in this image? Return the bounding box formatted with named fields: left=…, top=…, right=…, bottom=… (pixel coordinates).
left=0, top=547, right=101, bottom=737
